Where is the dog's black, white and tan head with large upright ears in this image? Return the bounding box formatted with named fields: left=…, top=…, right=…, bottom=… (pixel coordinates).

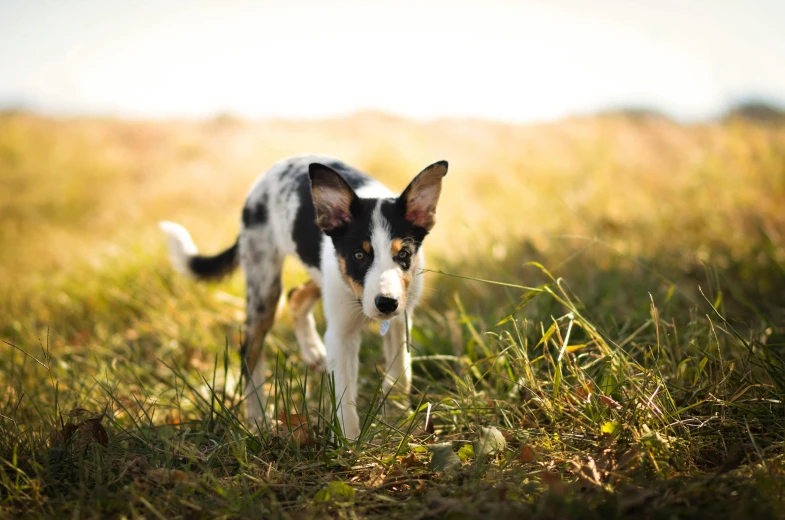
left=309, top=161, right=447, bottom=320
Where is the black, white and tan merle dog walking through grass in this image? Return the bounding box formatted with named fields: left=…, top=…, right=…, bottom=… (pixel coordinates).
left=160, top=155, right=448, bottom=439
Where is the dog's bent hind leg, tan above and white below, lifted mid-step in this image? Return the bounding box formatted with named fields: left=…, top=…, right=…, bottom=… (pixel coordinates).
left=289, top=280, right=327, bottom=372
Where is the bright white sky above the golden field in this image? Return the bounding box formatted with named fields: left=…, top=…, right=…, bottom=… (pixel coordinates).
left=0, top=0, right=785, bottom=121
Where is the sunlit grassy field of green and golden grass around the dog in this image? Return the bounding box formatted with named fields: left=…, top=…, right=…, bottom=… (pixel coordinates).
left=0, top=113, right=785, bottom=519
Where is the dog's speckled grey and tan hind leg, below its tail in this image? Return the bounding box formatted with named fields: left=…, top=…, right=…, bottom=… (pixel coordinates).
left=240, top=230, right=283, bottom=424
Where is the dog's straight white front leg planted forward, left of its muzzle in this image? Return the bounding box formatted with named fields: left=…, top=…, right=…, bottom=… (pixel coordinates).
left=324, top=320, right=360, bottom=440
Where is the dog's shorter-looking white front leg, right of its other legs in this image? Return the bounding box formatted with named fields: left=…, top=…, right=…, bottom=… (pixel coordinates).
left=382, top=313, right=412, bottom=417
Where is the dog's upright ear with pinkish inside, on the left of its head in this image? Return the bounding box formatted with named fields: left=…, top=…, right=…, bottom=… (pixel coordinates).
left=308, top=163, right=357, bottom=234
